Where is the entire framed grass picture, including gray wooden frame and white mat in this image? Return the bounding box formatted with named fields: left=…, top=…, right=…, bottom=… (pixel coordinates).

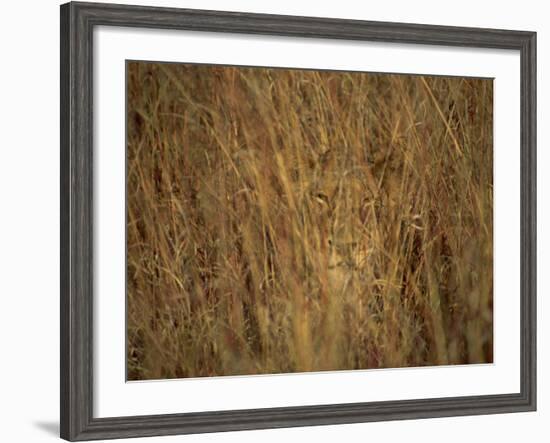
left=61, top=3, right=536, bottom=441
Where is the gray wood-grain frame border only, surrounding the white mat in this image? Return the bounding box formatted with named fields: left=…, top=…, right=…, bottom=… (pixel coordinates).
left=60, top=3, right=536, bottom=441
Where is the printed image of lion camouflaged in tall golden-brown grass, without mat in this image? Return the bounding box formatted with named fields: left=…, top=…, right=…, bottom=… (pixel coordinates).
left=127, top=62, right=493, bottom=380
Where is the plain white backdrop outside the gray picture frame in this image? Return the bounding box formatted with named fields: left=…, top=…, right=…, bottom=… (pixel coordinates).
left=0, top=0, right=550, bottom=442
